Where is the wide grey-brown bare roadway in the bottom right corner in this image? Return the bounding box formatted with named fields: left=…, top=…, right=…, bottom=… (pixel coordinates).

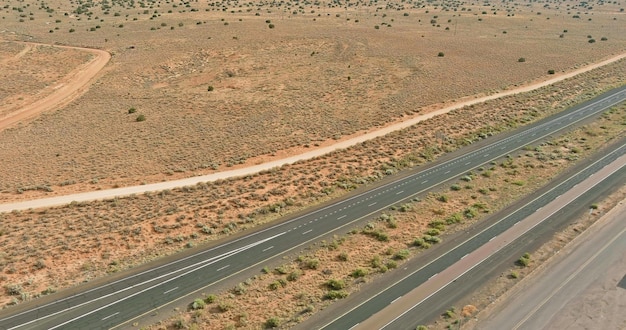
left=477, top=204, right=626, bottom=330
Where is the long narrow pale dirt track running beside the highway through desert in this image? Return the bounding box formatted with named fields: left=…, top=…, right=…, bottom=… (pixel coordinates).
left=0, top=50, right=626, bottom=212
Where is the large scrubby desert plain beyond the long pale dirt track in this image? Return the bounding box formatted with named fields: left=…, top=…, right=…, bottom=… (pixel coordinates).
left=0, top=1, right=626, bottom=200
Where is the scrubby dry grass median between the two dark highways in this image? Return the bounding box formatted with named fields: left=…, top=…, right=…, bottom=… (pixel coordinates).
left=143, top=104, right=626, bottom=329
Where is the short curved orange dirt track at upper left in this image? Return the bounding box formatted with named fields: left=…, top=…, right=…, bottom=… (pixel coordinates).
left=0, top=42, right=111, bottom=131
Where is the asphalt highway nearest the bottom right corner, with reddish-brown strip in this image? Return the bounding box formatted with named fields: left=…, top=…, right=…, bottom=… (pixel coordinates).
left=321, top=144, right=626, bottom=329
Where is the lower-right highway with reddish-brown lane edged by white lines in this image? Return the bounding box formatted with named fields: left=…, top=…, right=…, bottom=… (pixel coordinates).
left=344, top=144, right=626, bottom=330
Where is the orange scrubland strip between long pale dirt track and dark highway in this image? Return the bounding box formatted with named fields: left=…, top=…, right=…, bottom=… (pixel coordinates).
left=0, top=54, right=624, bottom=312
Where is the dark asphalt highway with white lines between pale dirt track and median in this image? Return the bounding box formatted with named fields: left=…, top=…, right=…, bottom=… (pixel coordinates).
left=0, top=86, right=626, bottom=329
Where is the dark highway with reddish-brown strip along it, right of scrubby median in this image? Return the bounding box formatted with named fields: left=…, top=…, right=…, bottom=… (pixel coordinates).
left=313, top=144, right=626, bottom=329
